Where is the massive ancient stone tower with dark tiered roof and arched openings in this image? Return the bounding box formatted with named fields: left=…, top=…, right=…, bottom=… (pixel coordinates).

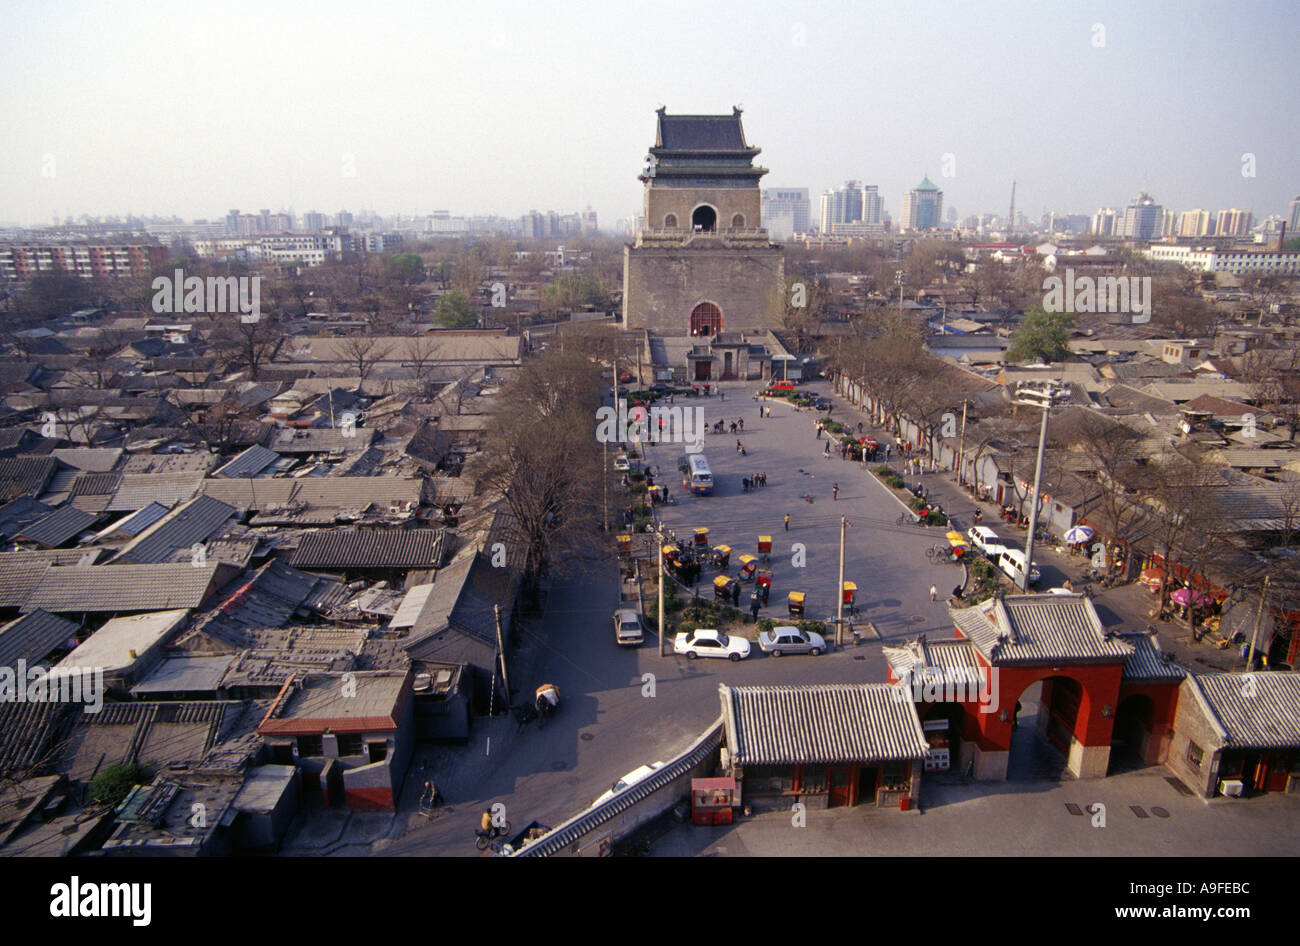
left=623, top=108, right=785, bottom=337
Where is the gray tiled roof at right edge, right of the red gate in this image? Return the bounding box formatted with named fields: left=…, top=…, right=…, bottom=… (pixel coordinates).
left=1183, top=672, right=1300, bottom=748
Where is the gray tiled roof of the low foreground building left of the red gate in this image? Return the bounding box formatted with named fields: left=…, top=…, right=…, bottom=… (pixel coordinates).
left=718, top=684, right=930, bottom=765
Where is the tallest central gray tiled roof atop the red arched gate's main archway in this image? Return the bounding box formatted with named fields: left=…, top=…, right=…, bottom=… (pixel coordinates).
left=949, top=595, right=1134, bottom=665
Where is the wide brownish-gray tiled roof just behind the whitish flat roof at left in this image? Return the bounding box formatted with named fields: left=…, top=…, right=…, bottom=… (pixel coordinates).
left=23, top=563, right=229, bottom=613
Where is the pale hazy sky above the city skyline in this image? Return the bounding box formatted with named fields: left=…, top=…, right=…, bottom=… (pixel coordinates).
left=0, top=0, right=1300, bottom=227
